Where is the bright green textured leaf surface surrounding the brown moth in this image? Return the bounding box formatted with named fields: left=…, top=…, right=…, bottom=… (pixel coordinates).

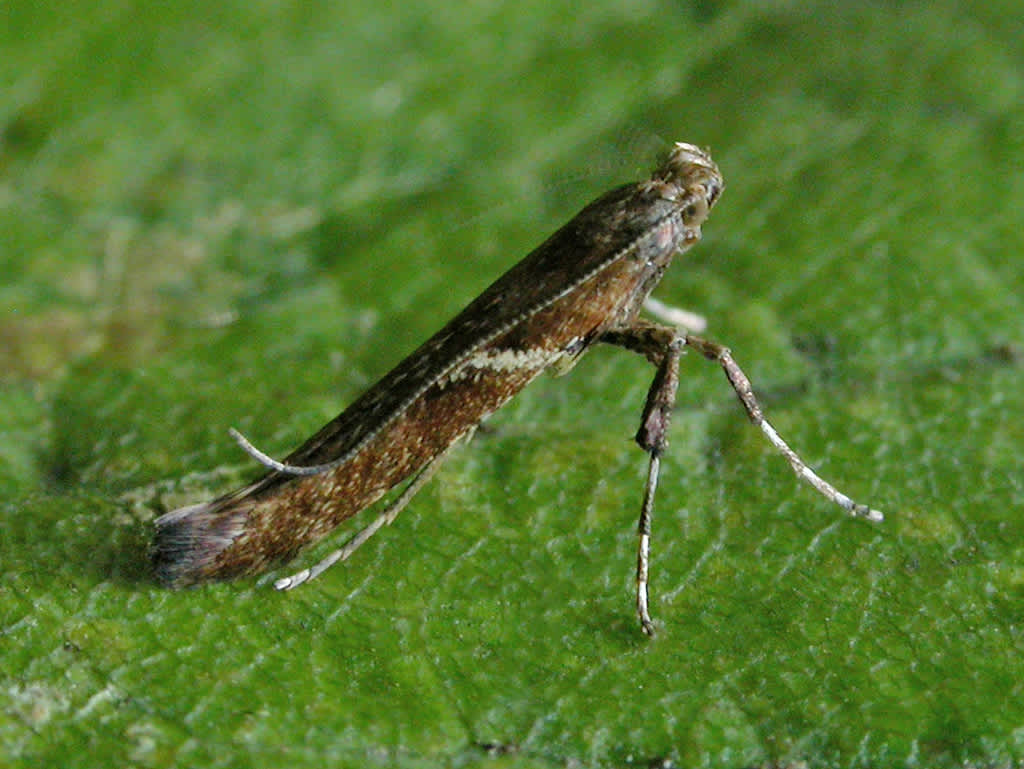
left=0, top=0, right=1024, bottom=768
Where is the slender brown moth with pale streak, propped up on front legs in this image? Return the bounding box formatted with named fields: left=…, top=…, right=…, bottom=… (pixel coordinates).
left=153, top=143, right=882, bottom=635
